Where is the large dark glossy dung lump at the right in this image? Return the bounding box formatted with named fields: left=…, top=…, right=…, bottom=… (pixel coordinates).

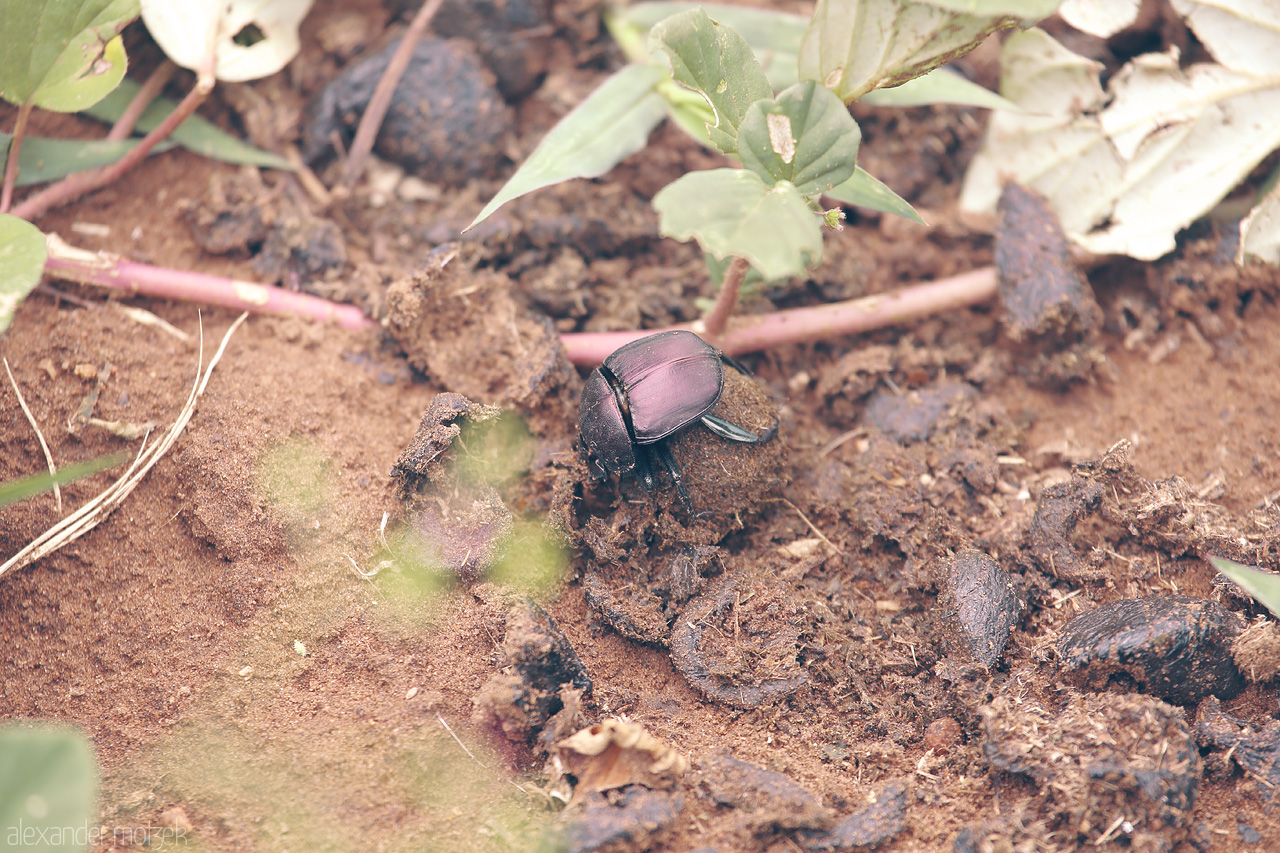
left=1057, top=596, right=1244, bottom=704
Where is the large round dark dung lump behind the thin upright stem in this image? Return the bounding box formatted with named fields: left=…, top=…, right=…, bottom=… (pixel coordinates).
left=303, top=38, right=511, bottom=186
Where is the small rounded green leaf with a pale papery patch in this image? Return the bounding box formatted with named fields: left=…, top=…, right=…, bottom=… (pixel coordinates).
left=737, top=81, right=863, bottom=196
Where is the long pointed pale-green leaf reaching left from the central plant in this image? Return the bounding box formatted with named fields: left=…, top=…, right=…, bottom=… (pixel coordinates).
left=465, top=65, right=667, bottom=231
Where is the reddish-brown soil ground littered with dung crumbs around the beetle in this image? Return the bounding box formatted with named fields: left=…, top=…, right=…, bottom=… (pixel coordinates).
left=0, top=3, right=1280, bottom=850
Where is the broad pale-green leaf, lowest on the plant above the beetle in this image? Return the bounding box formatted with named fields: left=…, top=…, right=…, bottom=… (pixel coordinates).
left=653, top=169, right=822, bottom=280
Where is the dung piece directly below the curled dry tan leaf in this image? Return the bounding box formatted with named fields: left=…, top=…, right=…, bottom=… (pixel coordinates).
left=563, top=785, right=685, bottom=853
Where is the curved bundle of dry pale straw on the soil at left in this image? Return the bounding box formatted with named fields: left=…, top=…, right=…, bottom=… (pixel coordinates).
left=0, top=314, right=248, bottom=578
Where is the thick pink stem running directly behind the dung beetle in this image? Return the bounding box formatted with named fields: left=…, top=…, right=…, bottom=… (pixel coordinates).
left=561, top=266, right=997, bottom=368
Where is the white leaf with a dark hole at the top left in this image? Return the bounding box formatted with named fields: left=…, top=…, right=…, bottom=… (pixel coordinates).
left=141, top=0, right=312, bottom=83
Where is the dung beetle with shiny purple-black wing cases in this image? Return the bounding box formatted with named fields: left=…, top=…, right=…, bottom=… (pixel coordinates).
left=579, top=330, right=778, bottom=507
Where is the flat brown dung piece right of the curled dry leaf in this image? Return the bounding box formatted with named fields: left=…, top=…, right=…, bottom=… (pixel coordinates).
left=699, top=754, right=835, bottom=834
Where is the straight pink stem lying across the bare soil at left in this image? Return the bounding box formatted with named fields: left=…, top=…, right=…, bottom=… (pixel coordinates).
left=45, top=240, right=376, bottom=329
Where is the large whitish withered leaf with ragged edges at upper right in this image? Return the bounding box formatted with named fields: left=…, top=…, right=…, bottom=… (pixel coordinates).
left=961, top=7, right=1280, bottom=260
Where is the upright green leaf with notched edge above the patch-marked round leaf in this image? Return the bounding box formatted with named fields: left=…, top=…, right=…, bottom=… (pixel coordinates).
left=649, top=9, right=773, bottom=154
